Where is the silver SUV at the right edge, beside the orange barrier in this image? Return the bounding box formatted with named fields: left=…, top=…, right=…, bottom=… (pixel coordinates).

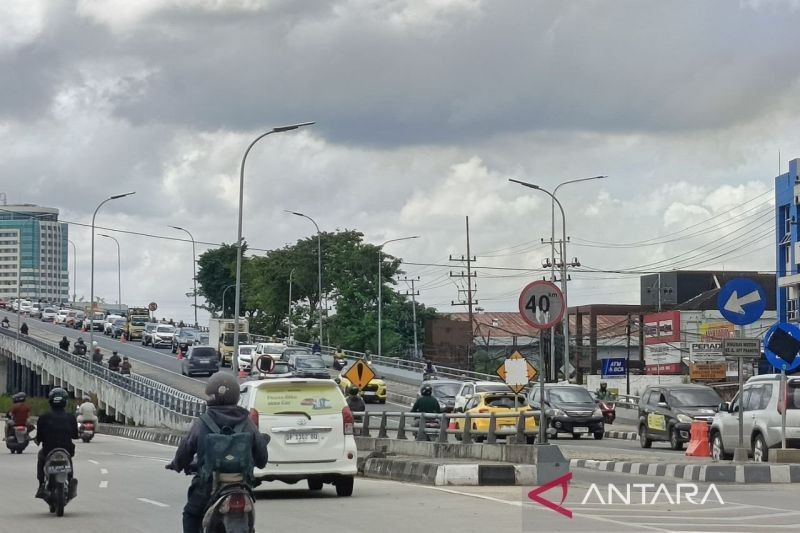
left=710, top=374, right=800, bottom=461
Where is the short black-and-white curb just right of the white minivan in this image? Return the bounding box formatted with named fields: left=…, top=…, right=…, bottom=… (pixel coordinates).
left=363, top=457, right=536, bottom=486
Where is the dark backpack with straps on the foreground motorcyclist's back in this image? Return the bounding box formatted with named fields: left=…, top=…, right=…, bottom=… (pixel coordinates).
left=199, top=413, right=255, bottom=484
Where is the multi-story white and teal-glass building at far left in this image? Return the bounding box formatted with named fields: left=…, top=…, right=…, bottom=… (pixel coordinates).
left=0, top=204, right=69, bottom=303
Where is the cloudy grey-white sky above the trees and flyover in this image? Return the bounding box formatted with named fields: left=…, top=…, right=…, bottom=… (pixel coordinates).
left=0, top=0, right=800, bottom=319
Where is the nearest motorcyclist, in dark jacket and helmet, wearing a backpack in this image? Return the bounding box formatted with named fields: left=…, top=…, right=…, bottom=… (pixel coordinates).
left=165, top=372, right=267, bottom=533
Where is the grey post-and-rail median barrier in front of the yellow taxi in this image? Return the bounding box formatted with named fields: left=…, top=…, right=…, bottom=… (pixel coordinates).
left=353, top=411, right=540, bottom=444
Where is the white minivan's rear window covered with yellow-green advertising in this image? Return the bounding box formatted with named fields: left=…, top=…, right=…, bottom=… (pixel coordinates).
left=254, top=382, right=345, bottom=416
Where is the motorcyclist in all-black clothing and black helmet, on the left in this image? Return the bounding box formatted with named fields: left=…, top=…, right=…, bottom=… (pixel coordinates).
left=35, top=387, right=78, bottom=498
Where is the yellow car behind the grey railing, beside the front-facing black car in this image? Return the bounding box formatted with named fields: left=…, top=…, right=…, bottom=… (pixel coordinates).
left=455, top=391, right=537, bottom=444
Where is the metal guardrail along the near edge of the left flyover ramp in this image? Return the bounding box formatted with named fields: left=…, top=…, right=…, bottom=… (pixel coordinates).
left=0, top=328, right=206, bottom=417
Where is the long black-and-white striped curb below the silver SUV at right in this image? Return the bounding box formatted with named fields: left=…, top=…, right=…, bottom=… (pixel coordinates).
left=569, top=459, right=800, bottom=483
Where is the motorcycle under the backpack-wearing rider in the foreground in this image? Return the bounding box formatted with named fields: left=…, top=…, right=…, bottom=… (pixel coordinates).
left=167, top=463, right=256, bottom=533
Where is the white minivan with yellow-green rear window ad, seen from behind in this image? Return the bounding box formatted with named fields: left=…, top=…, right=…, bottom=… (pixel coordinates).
left=239, top=378, right=357, bottom=496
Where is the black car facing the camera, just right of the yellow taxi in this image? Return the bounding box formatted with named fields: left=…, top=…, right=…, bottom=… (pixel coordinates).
left=528, top=385, right=605, bottom=440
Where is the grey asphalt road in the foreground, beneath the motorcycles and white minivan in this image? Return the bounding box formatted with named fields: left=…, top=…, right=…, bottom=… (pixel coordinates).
left=0, top=435, right=800, bottom=533
